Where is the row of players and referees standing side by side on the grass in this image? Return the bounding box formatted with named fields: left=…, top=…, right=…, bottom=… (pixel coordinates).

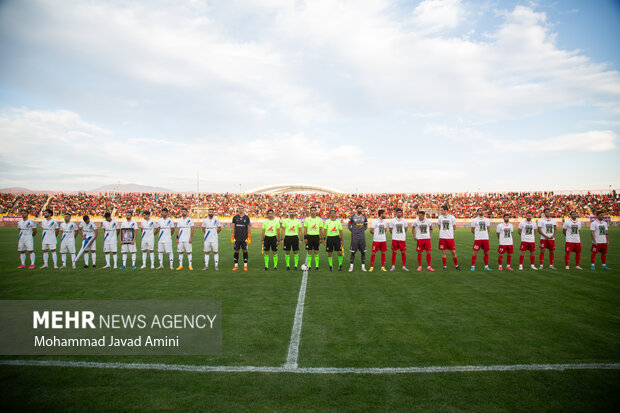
left=18, top=205, right=609, bottom=271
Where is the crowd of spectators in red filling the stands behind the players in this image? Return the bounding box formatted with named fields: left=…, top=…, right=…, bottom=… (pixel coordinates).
left=0, top=191, right=620, bottom=218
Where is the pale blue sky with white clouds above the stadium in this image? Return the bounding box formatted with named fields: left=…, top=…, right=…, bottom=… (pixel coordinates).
left=0, top=0, right=620, bottom=192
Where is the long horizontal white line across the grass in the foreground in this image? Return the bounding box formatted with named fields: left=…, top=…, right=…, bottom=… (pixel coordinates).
left=0, top=360, right=620, bottom=374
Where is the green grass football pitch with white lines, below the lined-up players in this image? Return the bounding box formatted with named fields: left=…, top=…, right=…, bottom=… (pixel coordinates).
left=0, top=228, right=620, bottom=411
